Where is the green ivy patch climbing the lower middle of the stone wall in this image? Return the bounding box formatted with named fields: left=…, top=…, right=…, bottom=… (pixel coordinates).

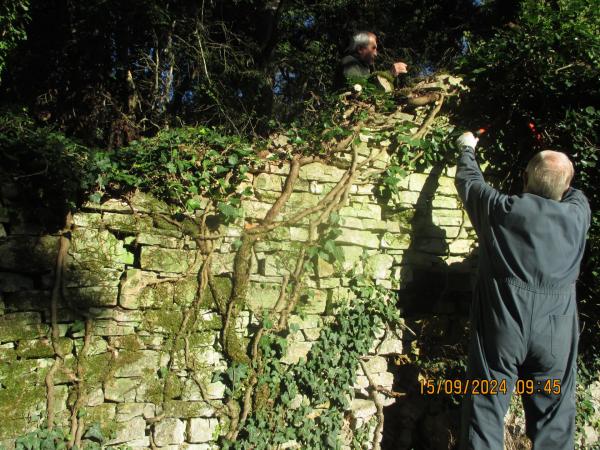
left=223, top=268, right=400, bottom=449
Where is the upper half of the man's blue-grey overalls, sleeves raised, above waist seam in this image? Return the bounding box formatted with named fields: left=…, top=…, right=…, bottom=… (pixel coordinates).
left=455, top=147, right=591, bottom=287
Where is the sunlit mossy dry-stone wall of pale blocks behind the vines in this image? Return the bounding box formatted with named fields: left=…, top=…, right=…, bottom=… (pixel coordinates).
left=0, top=121, right=476, bottom=449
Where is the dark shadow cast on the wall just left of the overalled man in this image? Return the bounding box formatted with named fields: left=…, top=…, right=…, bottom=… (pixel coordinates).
left=382, top=163, right=475, bottom=450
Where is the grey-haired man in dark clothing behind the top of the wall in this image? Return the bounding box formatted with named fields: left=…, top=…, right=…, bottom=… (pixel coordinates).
left=338, top=31, right=407, bottom=84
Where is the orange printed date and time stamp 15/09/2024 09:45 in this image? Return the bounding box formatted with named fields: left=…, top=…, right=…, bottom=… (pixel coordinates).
left=419, top=378, right=561, bottom=395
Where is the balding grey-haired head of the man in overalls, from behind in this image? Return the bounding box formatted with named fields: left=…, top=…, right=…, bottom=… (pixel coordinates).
left=525, top=150, right=575, bottom=201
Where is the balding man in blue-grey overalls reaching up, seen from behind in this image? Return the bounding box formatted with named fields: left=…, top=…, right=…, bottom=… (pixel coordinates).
left=456, top=133, right=591, bottom=450
